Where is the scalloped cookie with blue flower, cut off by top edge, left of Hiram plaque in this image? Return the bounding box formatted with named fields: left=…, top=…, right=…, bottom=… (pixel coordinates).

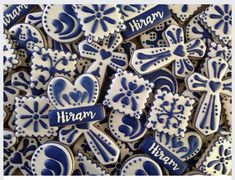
left=74, top=4, right=125, bottom=43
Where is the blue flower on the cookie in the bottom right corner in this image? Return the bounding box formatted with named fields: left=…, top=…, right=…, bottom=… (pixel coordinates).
left=207, top=144, right=232, bottom=175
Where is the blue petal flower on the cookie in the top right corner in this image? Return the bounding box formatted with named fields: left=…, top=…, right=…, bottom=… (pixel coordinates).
left=210, top=4, right=232, bottom=34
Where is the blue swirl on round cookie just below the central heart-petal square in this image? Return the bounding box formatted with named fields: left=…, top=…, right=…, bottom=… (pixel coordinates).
left=118, top=115, right=146, bottom=140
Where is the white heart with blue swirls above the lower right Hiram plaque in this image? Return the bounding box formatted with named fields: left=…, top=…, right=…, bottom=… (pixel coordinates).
left=155, top=131, right=202, bottom=161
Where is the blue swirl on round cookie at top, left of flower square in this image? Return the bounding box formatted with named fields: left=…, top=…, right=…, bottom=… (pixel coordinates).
left=52, top=5, right=82, bottom=40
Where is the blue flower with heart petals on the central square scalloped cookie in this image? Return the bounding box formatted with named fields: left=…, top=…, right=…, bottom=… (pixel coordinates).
left=113, top=78, right=145, bottom=111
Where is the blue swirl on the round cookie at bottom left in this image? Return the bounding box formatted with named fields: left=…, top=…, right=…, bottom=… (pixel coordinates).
left=41, top=146, right=69, bottom=175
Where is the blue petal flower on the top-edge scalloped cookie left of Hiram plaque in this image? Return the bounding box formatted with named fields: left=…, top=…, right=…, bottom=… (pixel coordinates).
left=81, top=4, right=116, bottom=33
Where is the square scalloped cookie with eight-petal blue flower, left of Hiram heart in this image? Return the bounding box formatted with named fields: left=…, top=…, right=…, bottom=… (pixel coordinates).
left=15, top=96, right=58, bottom=137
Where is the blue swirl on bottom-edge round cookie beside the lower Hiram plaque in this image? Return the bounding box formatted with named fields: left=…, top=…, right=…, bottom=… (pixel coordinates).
left=135, top=161, right=161, bottom=176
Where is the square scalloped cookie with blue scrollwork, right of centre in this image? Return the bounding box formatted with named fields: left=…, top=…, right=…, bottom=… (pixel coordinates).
left=146, top=90, right=194, bottom=137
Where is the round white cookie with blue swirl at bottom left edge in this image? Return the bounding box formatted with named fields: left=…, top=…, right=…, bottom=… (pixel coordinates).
left=31, top=142, right=74, bottom=176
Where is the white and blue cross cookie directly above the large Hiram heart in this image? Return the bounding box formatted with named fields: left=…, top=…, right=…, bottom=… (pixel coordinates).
left=79, top=33, right=128, bottom=87
